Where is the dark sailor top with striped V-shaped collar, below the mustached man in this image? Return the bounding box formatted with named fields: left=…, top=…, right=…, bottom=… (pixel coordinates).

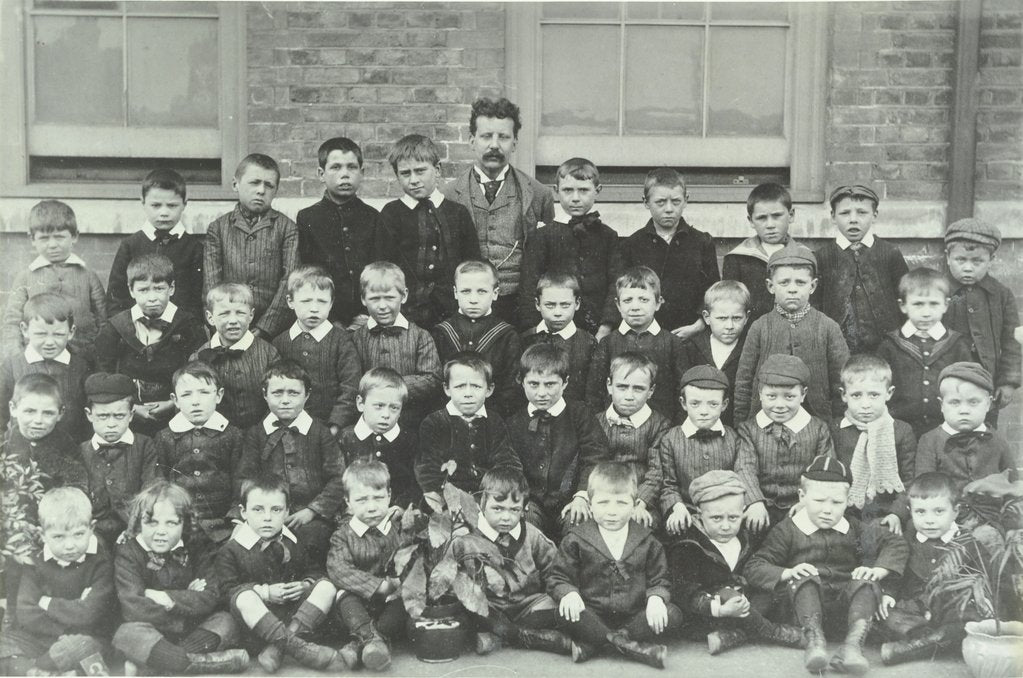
left=431, top=313, right=522, bottom=416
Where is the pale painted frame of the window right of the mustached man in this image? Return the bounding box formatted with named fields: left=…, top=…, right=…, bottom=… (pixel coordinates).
left=504, top=2, right=829, bottom=202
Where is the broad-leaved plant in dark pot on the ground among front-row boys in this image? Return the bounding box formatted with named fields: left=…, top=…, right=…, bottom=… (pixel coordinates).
left=393, top=461, right=507, bottom=662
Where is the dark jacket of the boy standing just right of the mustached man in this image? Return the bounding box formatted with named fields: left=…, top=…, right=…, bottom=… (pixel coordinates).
left=519, top=218, right=624, bottom=333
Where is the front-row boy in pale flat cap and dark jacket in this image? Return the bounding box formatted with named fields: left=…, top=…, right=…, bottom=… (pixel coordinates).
left=667, top=470, right=803, bottom=654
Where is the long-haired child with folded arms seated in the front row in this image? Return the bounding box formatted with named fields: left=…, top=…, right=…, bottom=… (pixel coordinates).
left=114, top=481, right=249, bottom=676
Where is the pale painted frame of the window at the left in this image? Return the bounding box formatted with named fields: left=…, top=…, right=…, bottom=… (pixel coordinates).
left=0, top=1, right=249, bottom=199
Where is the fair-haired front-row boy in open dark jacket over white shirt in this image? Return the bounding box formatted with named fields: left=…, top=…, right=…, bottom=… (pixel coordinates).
left=547, top=462, right=682, bottom=669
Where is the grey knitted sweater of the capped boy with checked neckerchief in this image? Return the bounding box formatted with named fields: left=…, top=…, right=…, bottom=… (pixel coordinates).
left=735, top=308, right=849, bottom=422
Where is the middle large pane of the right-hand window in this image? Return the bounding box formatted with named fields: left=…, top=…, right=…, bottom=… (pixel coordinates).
left=625, top=26, right=704, bottom=134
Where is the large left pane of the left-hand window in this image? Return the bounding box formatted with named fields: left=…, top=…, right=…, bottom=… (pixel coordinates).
left=33, top=16, right=124, bottom=125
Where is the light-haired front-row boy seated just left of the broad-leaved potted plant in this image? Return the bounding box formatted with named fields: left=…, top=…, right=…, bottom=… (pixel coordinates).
left=326, top=460, right=408, bottom=671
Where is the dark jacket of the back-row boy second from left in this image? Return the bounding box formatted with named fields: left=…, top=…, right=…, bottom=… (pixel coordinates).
left=106, top=231, right=205, bottom=318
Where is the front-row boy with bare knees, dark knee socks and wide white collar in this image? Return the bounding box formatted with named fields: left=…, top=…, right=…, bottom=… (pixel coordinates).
left=214, top=473, right=357, bottom=674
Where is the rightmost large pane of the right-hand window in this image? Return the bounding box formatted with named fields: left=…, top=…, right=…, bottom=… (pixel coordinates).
left=707, top=28, right=787, bottom=136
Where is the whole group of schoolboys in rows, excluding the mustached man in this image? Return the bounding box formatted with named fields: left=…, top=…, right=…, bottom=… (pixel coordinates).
left=0, top=108, right=1021, bottom=675
